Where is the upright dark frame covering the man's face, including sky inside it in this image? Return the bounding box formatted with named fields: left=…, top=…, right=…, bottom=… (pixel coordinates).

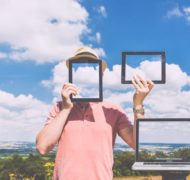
left=69, top=60, right=102, bottom=101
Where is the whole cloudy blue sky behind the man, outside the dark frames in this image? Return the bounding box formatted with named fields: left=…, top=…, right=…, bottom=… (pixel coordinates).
left=0, top=0, right=190, bottom=141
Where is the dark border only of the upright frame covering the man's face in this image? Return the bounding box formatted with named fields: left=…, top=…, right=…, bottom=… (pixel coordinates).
left=69, top=58, right=103, bottom=102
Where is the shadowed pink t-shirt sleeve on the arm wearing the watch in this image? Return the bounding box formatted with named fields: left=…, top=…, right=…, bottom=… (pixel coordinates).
left=117, top=108, right=131, bottom=132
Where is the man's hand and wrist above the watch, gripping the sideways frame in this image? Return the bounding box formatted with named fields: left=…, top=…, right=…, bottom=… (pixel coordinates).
left=132, top=75, right=154, bottom=107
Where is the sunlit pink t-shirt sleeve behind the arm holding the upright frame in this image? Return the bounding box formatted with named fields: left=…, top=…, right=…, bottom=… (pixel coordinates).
left=44, top=102, right=60, bottom=126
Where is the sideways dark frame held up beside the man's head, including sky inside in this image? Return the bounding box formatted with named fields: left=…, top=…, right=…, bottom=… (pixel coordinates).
left=122, top=52, right=165, bottom=84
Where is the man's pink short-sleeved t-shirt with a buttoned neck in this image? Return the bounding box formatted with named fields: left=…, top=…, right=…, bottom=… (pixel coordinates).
left=45, top=102, right=131, bottom=180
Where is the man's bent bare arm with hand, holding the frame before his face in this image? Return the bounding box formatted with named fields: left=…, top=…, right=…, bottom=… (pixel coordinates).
left=36, top=83, right=77, bottom=154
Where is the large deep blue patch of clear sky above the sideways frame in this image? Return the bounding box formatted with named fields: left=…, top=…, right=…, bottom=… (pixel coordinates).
left=86, top=0, right=190, bottom=73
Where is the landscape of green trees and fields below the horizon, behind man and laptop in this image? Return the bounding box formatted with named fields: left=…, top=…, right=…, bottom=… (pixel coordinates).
left=0, top=141, right=190, bottom=180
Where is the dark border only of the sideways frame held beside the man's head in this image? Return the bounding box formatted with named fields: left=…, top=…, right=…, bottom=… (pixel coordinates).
left=121, top=51, right=166, bottom=84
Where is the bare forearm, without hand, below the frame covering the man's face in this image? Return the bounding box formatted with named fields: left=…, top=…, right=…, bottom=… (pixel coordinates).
left=36, top=109, right=71, bottom=154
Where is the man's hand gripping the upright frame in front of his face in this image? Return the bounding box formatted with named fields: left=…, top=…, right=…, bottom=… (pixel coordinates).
left=61, top=83, right=78, bottom=109
